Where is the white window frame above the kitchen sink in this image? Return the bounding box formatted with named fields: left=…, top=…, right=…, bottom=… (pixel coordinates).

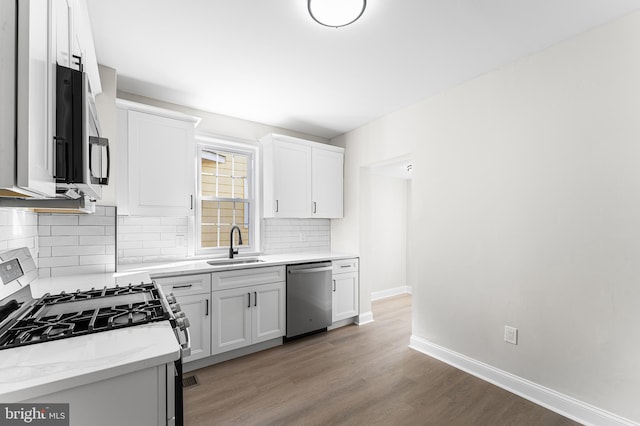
left=194, top=134, right=261, bottom=256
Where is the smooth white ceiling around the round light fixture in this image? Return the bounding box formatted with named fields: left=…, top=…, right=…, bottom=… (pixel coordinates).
left=87, top=0, right=640, bottom=138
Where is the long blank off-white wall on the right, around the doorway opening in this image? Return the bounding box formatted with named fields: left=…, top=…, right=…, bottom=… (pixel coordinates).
left=332, top=13, right=640, bottom=421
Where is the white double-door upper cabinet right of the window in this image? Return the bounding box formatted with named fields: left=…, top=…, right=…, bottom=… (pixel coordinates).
left=260, top=134, right=344, bottom=218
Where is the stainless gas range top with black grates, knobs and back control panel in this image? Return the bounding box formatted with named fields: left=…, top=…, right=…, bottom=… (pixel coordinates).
left=0, top=248, right=189, bottom=356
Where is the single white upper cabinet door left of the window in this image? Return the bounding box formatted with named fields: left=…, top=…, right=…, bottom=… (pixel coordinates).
left=128, top=111, right=196, bottom=216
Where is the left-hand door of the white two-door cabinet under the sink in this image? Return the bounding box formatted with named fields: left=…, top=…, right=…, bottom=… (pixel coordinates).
left=211, top=287, right=253, bottom=355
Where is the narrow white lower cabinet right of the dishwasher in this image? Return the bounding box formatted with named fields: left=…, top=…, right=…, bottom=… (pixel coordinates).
left=332, top=258, right=360, bottom=322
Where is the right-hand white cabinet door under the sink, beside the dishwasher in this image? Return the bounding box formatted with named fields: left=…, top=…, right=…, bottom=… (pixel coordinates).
left=252, top=282, right=286, bottom=343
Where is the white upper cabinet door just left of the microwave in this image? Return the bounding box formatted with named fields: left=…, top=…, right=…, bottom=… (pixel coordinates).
left=17, top=0, right=56, bottom=196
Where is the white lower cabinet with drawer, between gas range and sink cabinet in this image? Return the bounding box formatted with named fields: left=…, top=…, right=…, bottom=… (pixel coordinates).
left=154, top=274, right=211, bottom=363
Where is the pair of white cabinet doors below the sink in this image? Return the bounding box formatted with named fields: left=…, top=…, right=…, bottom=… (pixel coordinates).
left=211, top=282, right=286, bottom=355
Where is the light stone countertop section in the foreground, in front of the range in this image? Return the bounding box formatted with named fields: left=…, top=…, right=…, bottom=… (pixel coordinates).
left=0, top=321, right=180, bottom=403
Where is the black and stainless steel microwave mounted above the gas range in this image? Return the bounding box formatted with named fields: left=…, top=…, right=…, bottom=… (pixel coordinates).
left=55, top=65, right=110, bottom=198
